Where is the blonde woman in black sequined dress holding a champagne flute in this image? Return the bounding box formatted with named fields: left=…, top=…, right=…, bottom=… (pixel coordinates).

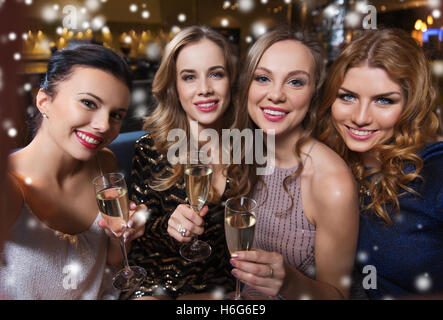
left=130, top=26, right=239, bottom=299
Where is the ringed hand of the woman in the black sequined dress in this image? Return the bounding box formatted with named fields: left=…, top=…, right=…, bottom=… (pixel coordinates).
left=168, top=204, right=209, bottom=242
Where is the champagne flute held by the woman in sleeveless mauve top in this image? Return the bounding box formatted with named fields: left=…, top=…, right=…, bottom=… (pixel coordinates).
left=225, top=197, right=257, bottom=300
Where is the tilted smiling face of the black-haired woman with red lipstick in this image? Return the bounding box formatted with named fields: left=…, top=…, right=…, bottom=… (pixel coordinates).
left=37, top=67, right=130, bottom=160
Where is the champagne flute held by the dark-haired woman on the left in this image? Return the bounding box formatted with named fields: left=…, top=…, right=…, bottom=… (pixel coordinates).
left=93, top=173, right=146, bottom=291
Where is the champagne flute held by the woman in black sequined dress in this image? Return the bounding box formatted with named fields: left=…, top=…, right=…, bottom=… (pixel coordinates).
left=180, top=151, right=213, bottom=262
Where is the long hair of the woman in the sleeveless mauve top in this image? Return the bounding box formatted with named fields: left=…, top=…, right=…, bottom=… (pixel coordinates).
left=228, top=25, right=325, bottom=211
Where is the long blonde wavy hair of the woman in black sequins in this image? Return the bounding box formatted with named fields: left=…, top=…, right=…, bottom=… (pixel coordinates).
left=143, top=26, right=236, bottom=198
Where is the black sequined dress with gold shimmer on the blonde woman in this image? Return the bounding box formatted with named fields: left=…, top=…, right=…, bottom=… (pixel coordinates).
left=129, top=134, right=235, bottom=298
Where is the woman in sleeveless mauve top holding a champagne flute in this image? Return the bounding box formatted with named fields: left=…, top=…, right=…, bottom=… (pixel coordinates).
left=228, top=26, right=358, bottom=299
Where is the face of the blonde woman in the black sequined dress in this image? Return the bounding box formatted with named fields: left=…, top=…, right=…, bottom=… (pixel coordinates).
left=176, top=39, right=230, bottom=127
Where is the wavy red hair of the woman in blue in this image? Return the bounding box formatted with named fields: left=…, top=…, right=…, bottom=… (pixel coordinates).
left=317, top=29, right=438, bottom=225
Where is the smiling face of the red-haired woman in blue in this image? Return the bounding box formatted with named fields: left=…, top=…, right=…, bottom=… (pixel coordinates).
left=331, top=65, right=406, bottom=165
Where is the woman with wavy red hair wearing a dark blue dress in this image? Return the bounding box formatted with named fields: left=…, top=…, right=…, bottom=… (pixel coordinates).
left=318, top=29, right=443, bottom=299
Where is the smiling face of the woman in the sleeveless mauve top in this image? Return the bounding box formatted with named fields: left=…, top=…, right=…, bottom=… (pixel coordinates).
left=248, top=40, right=315, bottom=137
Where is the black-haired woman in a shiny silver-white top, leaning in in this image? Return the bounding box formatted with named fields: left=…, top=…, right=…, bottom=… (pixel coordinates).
left=0, top=45, right=148, bottom=299
